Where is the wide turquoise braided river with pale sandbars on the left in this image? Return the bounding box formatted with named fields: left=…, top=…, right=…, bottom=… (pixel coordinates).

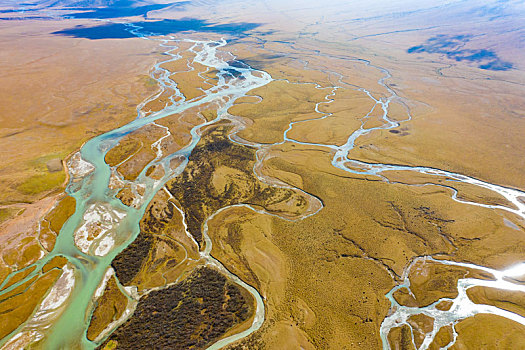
left=0, top=34, right=271, bottom=349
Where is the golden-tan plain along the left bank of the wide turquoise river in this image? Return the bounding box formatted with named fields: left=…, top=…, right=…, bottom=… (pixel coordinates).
left=0, top=20, right=161, bottom=344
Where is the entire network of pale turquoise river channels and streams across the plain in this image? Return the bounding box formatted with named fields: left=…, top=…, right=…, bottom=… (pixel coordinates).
left=0, top=19, right=525, bottom=349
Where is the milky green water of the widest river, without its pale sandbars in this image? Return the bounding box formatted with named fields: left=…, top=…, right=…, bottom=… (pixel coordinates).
left=44, top=37, right=270, bottom=349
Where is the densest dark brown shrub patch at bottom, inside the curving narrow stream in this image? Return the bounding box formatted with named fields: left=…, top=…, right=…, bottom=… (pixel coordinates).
left=101, top=267, right=254, bottom=350
